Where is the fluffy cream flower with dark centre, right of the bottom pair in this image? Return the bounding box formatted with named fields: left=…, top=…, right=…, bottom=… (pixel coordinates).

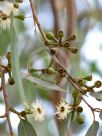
left=56, top=99, right=71, bottom=119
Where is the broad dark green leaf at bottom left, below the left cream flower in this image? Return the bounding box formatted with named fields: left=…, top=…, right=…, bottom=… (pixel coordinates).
left=18, top=119, right=37, bottom=136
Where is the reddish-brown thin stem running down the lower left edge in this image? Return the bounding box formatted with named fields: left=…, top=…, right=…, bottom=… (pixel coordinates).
left=2, top=75, right=13, bottom=136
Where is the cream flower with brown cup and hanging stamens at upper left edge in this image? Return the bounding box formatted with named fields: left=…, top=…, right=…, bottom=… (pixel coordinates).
left=0, top=14, right=11, bottom=30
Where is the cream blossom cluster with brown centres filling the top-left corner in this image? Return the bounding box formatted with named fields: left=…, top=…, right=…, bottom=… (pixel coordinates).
left=0, top=0, right=23, bottom=30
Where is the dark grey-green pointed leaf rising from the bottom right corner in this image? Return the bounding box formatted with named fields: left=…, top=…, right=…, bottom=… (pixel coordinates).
left=85, top=121, right=99, bottom=136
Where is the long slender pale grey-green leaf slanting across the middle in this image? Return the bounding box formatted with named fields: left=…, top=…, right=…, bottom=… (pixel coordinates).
left=22, top=73, right=67, bottom=92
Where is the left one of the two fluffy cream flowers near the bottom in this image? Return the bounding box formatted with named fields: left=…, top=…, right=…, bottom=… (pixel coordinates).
left=32, top=100, right=45, bottom=122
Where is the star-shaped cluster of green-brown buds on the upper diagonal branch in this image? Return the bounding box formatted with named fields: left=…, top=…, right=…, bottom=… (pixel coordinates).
left=45, top=31, right=77, bottom=55
